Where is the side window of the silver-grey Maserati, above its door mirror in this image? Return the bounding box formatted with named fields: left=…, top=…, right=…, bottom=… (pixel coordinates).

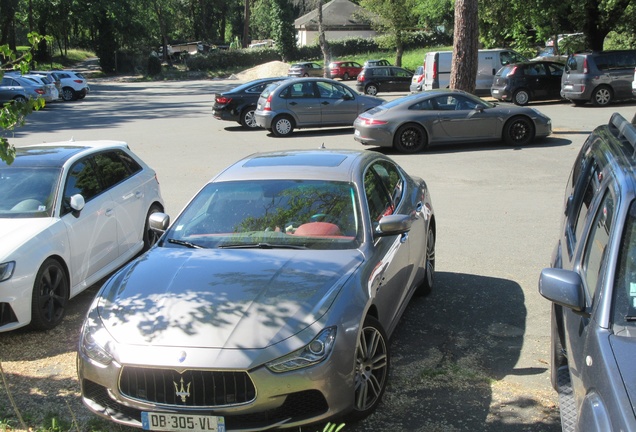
left=364, top=161, right=404, bottom=221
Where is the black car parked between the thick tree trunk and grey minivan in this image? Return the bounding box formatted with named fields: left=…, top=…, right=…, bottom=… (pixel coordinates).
left=490, top=61, right=564, bottom=105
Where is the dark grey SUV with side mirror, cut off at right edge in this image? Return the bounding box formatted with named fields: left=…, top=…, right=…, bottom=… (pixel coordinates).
left=539, top=114, right=636, bottom=431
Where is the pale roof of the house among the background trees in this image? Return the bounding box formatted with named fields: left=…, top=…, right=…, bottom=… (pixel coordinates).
left=294, top=0, right=371, bottom=30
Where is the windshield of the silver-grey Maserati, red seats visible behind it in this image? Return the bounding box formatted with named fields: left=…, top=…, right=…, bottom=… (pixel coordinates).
left=162, top=180, right=361, bottom=249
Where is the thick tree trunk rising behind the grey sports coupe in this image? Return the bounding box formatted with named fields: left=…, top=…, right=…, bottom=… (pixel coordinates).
left=450, top=0, right=479, bottom=93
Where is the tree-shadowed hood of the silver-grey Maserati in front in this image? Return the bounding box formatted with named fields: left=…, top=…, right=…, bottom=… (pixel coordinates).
left=97, top=247, right=362, bottom=349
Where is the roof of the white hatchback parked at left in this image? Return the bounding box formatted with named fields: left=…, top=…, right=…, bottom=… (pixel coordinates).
left=6, top=140, right=128, bottom=167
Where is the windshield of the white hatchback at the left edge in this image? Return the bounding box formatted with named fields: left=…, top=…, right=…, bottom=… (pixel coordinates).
left=0, top=166, right=60, bottom=218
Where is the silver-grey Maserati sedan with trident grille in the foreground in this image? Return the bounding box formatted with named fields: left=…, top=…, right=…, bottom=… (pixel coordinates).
left=78, top=149, right=436, bottom=431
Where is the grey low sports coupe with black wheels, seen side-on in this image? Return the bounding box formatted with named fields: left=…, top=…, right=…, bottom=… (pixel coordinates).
left=353, top=89, right=552, bottom=153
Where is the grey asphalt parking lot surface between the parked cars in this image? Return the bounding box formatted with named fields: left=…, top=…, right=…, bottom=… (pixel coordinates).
left=4, top=80, right=636, bottom=432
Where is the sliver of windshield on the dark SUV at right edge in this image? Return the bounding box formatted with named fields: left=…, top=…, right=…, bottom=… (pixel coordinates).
left=612, top=201, right=636, bottom=336
